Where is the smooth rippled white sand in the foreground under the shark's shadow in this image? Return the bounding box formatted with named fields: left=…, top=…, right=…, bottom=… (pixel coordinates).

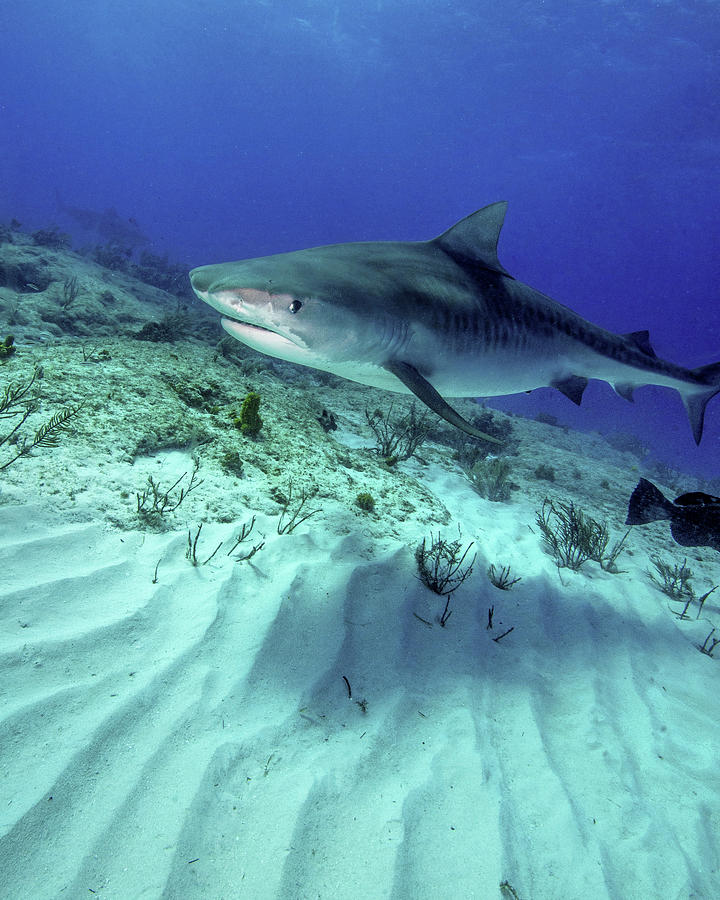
left=0, top=430, right=720, bottom=898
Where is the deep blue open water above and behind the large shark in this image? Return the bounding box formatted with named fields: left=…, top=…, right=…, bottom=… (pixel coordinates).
left=0, top=0, right=720, bottom=474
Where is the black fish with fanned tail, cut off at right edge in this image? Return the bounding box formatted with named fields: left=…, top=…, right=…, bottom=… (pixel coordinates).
left=625, top=478, right=720, bottom=551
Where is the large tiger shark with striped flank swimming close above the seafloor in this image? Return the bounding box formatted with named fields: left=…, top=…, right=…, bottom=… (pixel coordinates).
left=190, top=202, right=720, bottom=444
